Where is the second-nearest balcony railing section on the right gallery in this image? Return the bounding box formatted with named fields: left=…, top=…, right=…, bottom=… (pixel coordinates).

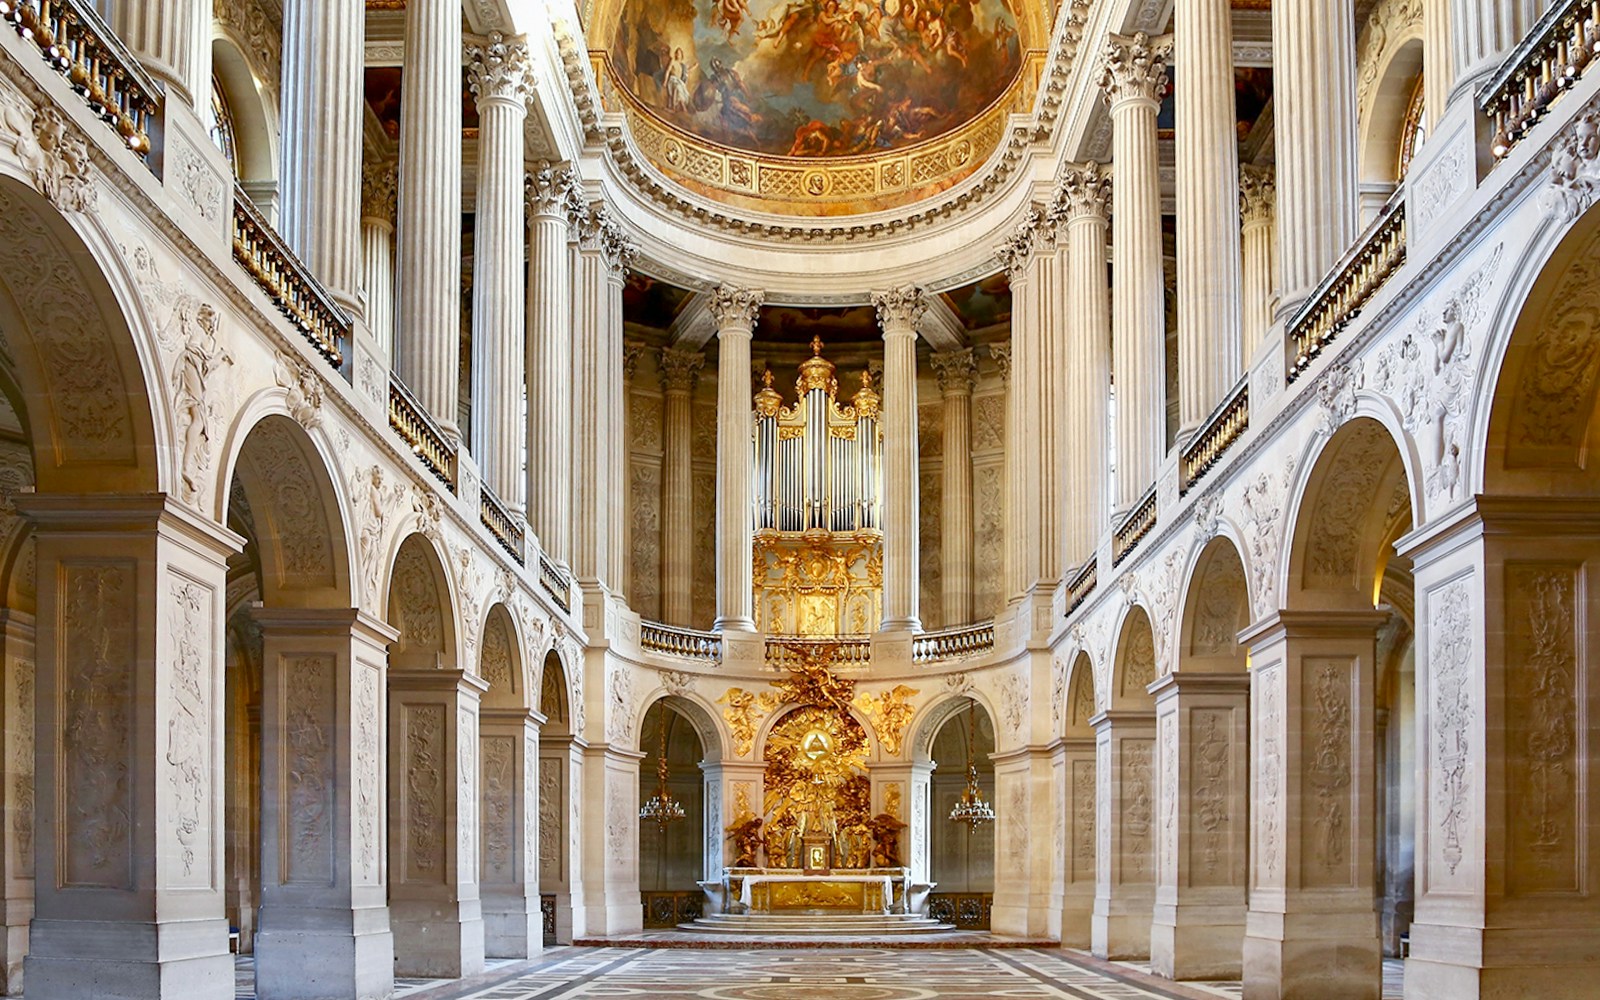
left=1288, top=187, right=1405, bottom=382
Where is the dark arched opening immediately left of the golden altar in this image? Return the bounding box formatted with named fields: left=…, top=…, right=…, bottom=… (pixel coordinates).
left=638, top=698, right=707, bottom=928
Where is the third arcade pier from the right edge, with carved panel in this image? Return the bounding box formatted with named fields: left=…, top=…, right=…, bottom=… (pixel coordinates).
left=1150, top=670, right=1250, bottom=979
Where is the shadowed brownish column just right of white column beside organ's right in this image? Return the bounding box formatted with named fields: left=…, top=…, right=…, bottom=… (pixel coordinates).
left=930, top=347, right=978, bottom=626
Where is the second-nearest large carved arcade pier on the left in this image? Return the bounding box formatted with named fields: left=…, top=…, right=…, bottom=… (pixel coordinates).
left=254, top=608, right=397, bottom=1000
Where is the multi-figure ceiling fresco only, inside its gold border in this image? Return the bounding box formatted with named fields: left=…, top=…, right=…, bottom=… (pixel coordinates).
left=610, top=0, right=1022, bottom=158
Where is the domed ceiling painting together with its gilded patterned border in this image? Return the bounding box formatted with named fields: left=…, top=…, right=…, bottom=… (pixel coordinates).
left=589, top=0, right=1043, bottom=214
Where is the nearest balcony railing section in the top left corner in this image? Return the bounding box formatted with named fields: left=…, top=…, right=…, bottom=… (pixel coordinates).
left=0, top=0, right=162, bottom=166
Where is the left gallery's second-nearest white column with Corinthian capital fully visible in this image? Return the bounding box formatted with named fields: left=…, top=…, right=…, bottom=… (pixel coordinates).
left=525, top=163, right=573, bottom=562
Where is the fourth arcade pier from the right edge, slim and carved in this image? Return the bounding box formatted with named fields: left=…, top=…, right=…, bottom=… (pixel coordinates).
left=1090, top=709, right=1157, bottom=960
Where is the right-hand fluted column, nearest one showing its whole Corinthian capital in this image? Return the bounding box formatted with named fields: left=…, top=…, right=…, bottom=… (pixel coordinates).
left=1101, top=33, right=1171, bottom=510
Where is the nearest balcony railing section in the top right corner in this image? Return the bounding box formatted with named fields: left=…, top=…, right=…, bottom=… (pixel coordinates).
left=1478, top=0, right=1600, bottom=162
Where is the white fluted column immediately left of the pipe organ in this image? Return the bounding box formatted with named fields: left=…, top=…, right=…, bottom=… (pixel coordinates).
left=710, top=285, right=765, bottom=632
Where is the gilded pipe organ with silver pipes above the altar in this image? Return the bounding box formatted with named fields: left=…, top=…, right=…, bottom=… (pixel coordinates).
left=752, top=338, right=883, bottom=635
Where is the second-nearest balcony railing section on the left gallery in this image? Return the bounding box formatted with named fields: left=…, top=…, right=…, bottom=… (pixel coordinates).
left=234, top=181, right=352, bottom=368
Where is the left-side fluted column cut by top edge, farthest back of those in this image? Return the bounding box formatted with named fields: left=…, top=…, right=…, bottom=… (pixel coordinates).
left=395, top=0, right=461, bottom=438
